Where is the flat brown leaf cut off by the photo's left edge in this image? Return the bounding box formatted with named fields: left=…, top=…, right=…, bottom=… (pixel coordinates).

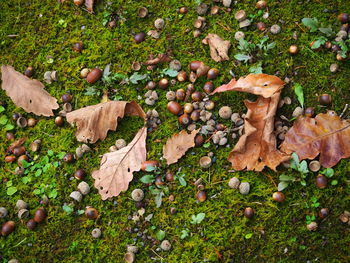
left=1, top=65, right=59, bottom=116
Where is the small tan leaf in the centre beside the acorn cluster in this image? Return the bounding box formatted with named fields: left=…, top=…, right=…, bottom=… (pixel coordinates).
left=163, top=130, right=199, bottom=165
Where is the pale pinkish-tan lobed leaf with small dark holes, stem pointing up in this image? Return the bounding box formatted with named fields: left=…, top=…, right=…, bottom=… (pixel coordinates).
left=92, top=127, right=147, bottom=200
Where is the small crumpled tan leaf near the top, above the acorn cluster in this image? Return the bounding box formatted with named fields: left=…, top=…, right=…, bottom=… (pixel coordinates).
left=202, top=33, right=231, bottom=62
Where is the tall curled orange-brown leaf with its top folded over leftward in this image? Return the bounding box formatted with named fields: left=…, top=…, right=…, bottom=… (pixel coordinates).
left=214, top=74, right=290, bottom=171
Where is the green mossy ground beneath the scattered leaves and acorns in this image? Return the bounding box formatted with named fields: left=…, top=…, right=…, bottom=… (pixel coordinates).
left=0, top=0, right=350, bottom=262
